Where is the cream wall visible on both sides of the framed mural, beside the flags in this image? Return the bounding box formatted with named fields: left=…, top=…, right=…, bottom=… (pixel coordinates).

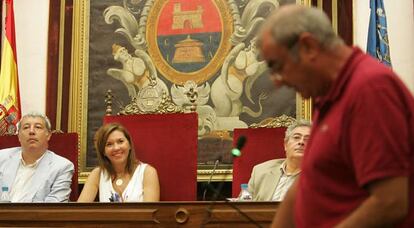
left=14, top=0, right=414, bottom=114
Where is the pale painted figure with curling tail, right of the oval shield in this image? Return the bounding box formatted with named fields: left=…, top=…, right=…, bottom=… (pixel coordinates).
left=211, top=39, right=267, bottom=129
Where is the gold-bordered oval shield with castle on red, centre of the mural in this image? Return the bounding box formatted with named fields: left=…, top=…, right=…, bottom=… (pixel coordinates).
left=146, top=0, right=233, bottom=85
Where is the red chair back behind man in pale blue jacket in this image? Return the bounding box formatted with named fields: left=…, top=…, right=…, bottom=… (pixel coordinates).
left=0, top=133, right=78, bottom=201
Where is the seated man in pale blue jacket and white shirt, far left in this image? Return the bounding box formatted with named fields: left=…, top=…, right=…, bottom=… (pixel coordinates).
left=0, top=113, right=74, bottom=202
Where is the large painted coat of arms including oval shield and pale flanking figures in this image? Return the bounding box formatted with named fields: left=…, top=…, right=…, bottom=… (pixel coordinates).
left=103, top=0, right=286, bottom=136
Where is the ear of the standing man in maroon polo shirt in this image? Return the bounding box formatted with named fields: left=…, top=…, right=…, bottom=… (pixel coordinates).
left=298, top=32, right=321, bottom=61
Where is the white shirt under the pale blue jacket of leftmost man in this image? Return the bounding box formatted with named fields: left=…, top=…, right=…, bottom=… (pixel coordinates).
left=9, top=153, right=45, bottom=202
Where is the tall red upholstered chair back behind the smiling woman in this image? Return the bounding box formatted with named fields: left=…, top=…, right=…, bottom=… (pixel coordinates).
left=104, top=113, right=198, bottom=201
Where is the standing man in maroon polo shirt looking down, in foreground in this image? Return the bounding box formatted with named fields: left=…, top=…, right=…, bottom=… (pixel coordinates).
left=259, top=5, right=414, bottom=227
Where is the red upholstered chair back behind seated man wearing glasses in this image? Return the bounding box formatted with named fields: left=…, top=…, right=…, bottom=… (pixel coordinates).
left=232, top=127, right=286, bottom=197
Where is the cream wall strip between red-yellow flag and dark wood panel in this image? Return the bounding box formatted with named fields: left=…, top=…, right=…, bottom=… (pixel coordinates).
left=14, top=0, right=49, bottom=115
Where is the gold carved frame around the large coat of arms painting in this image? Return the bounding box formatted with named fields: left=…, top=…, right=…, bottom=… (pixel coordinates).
left=68, top=0, right=311, bottom=183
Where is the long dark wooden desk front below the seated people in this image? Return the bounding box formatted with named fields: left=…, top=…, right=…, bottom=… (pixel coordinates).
left=0, top=202, right=278, bottom=227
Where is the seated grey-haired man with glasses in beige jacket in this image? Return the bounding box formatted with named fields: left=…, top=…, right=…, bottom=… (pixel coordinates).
left=248, top=120, right=311, bottom=201
